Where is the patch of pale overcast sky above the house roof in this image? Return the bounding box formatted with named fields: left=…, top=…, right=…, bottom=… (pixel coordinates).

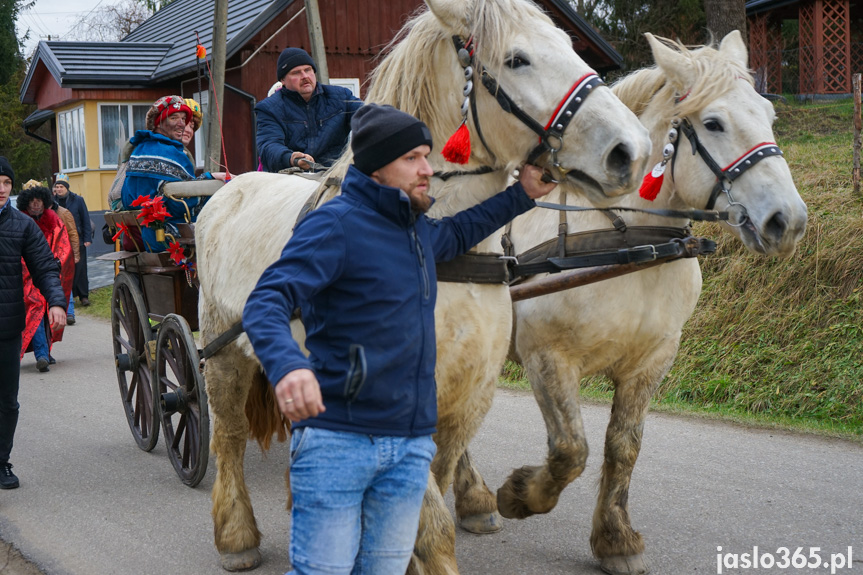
left=18, top=0, right=105, bottom=56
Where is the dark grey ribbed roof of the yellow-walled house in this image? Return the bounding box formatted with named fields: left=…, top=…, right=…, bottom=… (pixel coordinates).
left=20, top=0, right=295, bottom=102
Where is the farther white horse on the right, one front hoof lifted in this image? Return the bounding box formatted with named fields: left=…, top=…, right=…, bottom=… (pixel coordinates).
left=486, top=32, right=806, bottom=574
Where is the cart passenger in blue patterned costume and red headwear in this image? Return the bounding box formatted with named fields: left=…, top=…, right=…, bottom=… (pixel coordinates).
left=122, top=96, right=225, bottom=252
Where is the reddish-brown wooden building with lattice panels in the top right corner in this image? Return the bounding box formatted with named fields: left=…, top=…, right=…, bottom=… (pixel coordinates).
left=746, top=0, right=863, bottom=97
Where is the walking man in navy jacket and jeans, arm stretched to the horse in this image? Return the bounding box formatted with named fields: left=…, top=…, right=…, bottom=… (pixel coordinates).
left=243, top=104, right=554, bottom=575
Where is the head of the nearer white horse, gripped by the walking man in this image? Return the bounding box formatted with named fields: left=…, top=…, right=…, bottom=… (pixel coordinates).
left=367, top=0, right=650, bottom=200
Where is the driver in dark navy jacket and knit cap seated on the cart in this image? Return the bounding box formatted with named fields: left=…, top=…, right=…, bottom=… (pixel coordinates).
left=255, top=48, right=363, bottom=172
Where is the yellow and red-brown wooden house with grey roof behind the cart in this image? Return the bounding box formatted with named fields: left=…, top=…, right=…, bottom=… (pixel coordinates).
left=20, top=0, right=623, bottom=210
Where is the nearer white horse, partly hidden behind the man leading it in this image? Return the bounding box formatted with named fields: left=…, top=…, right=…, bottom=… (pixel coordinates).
left=196, top=0, right=650, bottom=573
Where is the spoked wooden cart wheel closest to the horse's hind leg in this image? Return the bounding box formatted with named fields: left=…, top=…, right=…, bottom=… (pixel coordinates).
left=153, top=314, right=210, bottom=487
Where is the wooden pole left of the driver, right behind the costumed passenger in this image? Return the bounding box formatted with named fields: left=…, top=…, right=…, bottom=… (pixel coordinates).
left=204, top=0, right=228, bottom=172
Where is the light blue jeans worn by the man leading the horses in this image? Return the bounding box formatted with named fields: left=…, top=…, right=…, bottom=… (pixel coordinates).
left=289, top=427, right=437, bottom=575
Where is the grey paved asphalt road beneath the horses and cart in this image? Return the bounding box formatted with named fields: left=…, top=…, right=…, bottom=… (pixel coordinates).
left=0, top=316, right=863, bottom=575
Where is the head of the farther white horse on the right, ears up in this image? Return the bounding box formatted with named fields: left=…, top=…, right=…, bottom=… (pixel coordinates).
left=615, top=31, right=806, bottom=257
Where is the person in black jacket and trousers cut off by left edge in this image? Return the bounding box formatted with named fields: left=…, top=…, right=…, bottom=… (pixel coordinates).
left=0, top=157, right=66, bottom=489
